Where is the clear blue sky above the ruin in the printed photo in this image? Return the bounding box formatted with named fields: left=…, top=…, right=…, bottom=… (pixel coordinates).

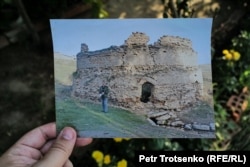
left=50, top=18, right=212, bottom=64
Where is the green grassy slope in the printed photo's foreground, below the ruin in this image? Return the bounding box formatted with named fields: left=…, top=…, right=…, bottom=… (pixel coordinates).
left=56, top=90, right=214, bottom=138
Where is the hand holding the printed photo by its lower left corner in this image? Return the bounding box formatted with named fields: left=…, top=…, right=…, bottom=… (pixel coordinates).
left=0, top=123, right=92, bottom=167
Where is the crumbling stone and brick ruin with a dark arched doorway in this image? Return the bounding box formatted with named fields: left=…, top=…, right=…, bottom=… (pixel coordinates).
left=72, top=32, right=203, bottom=114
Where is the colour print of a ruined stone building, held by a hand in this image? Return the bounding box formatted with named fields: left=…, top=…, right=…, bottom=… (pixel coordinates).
left=50, top=18, right=215, bottom=138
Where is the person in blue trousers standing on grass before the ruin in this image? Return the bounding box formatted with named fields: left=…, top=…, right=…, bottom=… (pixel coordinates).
left=99, top=82, right=109, bottom=113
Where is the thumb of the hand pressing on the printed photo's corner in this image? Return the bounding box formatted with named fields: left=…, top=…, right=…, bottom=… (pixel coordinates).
left=34, top=127, right=76, bottom=167
